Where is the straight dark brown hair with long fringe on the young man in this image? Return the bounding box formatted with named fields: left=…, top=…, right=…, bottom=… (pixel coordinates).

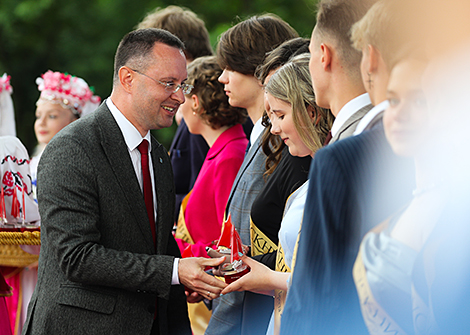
left=217, top=14, right=299, bottom=75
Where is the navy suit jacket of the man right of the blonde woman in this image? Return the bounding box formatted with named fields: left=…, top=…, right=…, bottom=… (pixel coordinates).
left=281, top=122, right=414, bottom=334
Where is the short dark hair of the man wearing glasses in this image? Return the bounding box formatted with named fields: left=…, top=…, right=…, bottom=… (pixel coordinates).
left=114, top=28, right=184, bottom=81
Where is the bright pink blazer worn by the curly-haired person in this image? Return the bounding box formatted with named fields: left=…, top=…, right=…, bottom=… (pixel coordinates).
left=176, top=124, right=248, bottom=257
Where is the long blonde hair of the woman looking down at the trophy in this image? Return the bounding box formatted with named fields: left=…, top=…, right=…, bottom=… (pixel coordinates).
left=266, top=53, right=334, bottom=153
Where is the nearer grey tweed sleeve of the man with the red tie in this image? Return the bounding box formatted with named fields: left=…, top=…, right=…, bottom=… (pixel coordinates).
left=38, top=137, right=174, bottom=299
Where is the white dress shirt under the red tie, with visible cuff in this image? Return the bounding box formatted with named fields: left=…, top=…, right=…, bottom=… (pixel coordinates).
left=106, top=98, right=180, bottom=285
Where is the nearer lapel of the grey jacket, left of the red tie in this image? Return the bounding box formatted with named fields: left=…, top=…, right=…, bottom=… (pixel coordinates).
left=97, top=103, right=154, bottom=253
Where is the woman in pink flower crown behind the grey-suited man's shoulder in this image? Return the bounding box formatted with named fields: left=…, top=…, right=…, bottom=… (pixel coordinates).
left=31, top=70, right=101, bottom=197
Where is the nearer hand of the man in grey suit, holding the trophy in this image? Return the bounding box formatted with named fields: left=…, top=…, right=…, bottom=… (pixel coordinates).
left=178, top=257, right=227, bottom=300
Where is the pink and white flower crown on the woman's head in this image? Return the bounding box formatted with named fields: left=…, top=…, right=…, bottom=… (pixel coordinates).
left=36, top=70, right=101, bottom=117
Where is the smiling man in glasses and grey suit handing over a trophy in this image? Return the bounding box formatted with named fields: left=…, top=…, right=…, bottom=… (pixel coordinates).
left=23, top=29, right=225, bottom=334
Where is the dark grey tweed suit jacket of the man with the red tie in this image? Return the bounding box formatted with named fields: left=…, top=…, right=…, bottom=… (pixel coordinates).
left=23, top=104, right=191, bottom=335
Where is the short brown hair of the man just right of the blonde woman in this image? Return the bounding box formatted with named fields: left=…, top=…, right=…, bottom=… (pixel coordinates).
left=315, top=0, right=374, bottom=78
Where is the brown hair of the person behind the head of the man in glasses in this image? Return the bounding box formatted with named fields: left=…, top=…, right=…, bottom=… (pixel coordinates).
left=137, top=6, right=214, bottom=60
